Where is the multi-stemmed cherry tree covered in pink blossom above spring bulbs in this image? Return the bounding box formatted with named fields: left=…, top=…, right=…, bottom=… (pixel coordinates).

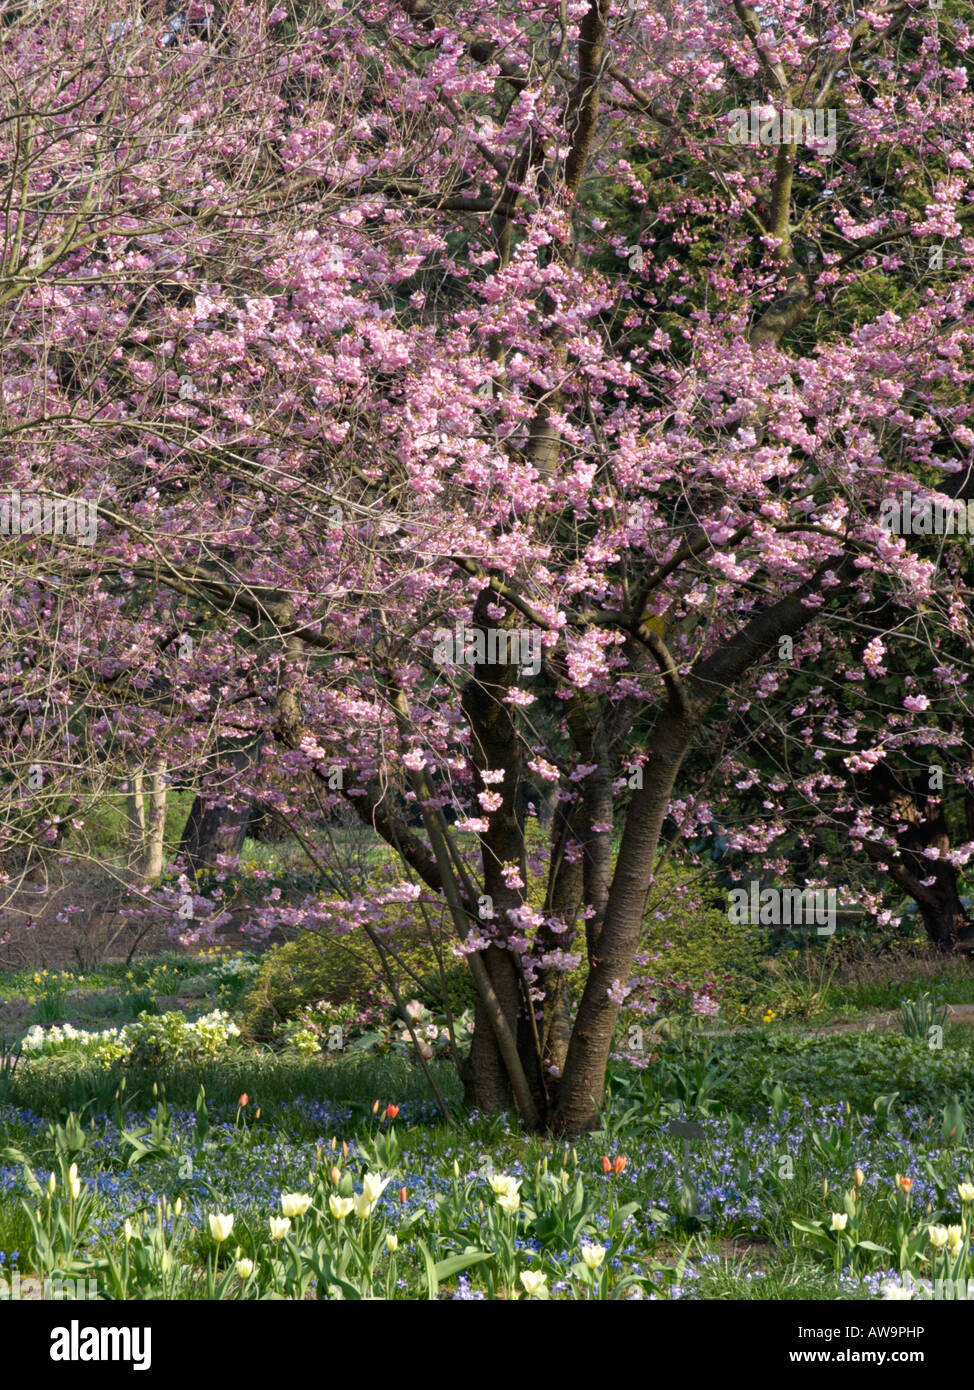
left=0, top=0, right=974, bottom=1134
